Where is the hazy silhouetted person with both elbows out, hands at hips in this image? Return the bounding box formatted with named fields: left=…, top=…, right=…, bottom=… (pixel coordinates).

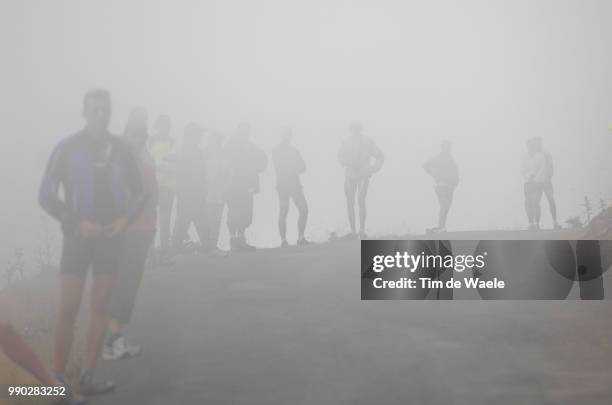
left=338, top=122, right=385, bottom=238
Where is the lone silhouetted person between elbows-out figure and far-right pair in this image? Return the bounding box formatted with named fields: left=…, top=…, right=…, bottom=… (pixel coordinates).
left=423, top=141, right=459, bottom=232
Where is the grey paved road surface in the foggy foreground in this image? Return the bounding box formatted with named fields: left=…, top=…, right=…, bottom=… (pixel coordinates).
left=94, top=241, right=612, bottom=405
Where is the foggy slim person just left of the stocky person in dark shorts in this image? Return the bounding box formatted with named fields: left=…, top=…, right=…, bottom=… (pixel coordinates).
left=202, top=132, right=229, bottom=255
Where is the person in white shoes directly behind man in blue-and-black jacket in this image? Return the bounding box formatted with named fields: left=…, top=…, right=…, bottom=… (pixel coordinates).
left=102, top=109, right=157, bottom=360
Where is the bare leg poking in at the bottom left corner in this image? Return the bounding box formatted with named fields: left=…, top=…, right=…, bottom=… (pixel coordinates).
left=0, top=321, right=58, bottom=386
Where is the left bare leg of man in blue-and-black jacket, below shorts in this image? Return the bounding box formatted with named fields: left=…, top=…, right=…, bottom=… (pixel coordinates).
left=53, top=272, right=87, bottom=376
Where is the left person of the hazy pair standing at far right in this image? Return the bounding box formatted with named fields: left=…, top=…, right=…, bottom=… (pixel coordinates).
left=521, top=138, right=552, bottom=230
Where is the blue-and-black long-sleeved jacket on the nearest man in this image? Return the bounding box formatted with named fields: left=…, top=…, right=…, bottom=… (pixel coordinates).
left=39, top=130, right=145, bottom=233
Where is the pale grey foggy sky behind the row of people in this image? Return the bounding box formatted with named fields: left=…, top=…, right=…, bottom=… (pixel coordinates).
left=0, top=0, right=612, bottom=261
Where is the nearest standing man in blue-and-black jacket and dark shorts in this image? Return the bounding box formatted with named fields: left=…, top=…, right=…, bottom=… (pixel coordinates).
left=39, top=89, right=144, bottom=395
